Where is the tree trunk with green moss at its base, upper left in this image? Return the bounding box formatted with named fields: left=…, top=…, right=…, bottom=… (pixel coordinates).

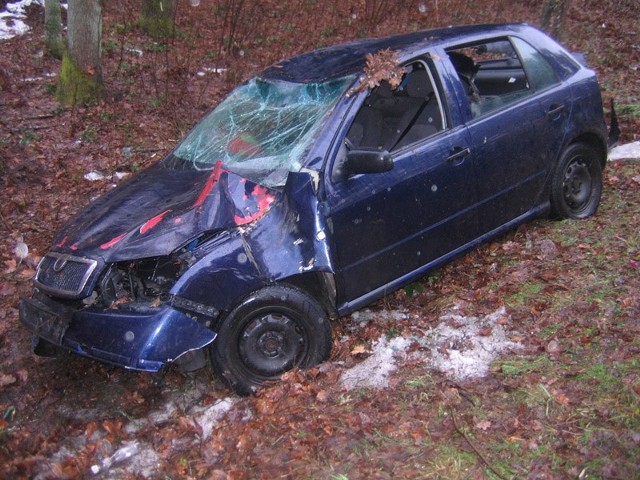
left=57, top=0, right=102, bottom=105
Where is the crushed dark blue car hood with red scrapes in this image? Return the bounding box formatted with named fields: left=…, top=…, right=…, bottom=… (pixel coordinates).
left=54, top=162, right=281, bottom=262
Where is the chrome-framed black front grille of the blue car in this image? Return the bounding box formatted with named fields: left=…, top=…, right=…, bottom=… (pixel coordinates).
left=36, top=252, right=98, bottom=297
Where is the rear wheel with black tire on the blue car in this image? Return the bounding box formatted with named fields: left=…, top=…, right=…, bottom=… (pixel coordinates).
left=551, top=143, right=602, bottom=218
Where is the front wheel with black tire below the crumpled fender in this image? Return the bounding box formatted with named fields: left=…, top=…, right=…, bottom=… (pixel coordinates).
left=209, top=285, right=332, bottom=395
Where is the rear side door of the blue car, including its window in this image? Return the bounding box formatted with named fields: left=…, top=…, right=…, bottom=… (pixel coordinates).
left=447, top=38, right=548, bottom=233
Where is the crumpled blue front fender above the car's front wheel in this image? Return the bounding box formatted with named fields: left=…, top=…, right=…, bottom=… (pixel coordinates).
left=171, top=172, right=333, bottom=312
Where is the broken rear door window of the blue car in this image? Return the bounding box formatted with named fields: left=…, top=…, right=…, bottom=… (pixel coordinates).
left=447, top=39, right=532, bottom=118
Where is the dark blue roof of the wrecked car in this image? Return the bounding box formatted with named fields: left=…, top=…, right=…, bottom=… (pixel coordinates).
left=259, top=23, right=535, bottom=83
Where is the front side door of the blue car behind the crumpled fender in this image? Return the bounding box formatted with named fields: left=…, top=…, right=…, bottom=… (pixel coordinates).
left=326, top=62, right=477, bottom=304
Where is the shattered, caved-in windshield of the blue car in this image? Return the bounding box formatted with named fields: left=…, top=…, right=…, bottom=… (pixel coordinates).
left=173, top=77, right=353, bottom=187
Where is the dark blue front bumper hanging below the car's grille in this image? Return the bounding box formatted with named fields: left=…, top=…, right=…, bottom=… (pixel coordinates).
left=20, top=296, right=216, bottom=372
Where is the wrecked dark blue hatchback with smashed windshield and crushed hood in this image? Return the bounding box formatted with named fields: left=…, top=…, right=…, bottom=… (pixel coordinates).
left=20, top=24, right=616, bottom=393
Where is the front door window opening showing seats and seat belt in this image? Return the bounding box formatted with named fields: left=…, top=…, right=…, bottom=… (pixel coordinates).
left=347, top=61, right=445, bottom=152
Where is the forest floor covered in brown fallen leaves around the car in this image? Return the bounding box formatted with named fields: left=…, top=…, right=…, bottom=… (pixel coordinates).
left=0, top=0, right=640, bottom=480
